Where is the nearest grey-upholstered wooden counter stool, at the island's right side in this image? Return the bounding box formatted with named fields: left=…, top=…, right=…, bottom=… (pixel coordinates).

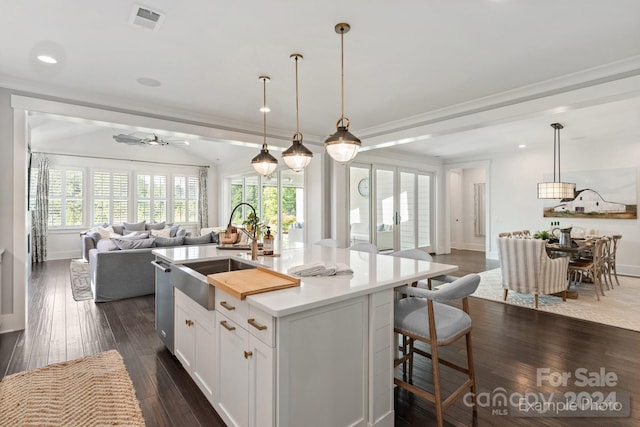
left=394, top=274, right=480, bottom=427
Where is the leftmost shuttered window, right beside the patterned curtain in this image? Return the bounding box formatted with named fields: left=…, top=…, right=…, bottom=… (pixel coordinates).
left=48, top=169, right=84, bottom=227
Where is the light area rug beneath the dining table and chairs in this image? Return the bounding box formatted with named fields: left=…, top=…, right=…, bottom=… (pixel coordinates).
left=472, top=268, right=640, bottom=332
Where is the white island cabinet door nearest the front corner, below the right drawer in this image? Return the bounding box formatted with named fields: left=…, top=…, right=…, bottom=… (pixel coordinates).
left=249, top=335, right=276, bottom=427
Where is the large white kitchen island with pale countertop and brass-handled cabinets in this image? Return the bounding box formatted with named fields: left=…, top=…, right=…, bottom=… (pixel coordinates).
left=153, top=245, right=457, bottom=426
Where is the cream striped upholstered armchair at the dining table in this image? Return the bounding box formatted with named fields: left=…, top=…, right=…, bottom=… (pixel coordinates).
left=498, top=237, right=569, bottom=308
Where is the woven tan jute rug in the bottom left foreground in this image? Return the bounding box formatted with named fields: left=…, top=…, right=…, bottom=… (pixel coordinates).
left=0, top=350, right=144, bottom=427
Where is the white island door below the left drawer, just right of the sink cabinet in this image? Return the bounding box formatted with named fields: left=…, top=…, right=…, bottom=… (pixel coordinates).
left=216, top=312, right=249, bottom=427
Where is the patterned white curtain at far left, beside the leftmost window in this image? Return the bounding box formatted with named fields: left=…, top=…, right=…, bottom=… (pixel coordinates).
left=31, top=154, right=49, bottom=262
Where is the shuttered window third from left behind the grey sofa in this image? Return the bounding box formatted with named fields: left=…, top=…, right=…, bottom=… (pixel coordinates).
left=136, top=174, right=167, bottom=222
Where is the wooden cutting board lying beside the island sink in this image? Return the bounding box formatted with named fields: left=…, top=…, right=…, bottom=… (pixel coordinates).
left=207, top=267, right=300, bottom=300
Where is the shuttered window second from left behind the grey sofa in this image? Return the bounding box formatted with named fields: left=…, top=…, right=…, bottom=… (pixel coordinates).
left=93, top=172, right=129, bottom=224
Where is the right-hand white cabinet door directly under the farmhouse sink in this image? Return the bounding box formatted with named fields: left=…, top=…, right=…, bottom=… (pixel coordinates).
left=193, top=306, right=216, bottom=404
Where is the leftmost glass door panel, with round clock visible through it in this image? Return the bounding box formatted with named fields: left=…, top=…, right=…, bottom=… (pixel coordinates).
left=349, top=166, right=371, bottom=244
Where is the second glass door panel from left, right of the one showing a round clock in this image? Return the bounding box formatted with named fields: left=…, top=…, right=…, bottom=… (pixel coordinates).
left=373, top=169, right=397, bottom=251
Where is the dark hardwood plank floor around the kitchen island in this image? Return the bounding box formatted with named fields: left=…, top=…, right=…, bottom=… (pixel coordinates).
left=0, top=251, right=640, bottom=427
